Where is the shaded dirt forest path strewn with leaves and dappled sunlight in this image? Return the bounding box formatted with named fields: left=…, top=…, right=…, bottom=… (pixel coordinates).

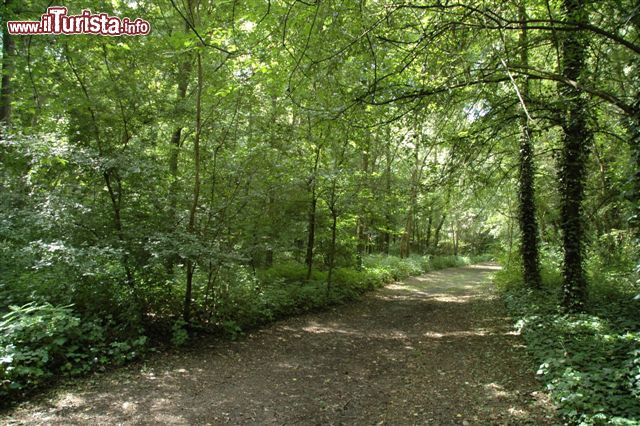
left=0, top=264, right=553, bottom=425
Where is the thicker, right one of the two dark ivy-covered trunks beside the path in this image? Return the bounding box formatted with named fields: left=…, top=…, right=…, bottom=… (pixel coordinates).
left=559, top=0, right=593, bottom=312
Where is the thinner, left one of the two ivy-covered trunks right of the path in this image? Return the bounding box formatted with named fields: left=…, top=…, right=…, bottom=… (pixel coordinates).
left=518, top=3, right=540, bottom=288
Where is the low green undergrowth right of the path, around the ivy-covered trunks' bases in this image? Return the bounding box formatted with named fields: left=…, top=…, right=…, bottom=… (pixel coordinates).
left=495, top=262, right=640, bottom=425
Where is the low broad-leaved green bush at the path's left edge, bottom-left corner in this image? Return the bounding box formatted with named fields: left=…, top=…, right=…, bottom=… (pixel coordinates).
left=0, top=302, right=146, bottom=401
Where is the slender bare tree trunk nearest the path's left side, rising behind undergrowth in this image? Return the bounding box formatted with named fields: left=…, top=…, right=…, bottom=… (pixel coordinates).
left=183, top=52, right=203, bottom=324
